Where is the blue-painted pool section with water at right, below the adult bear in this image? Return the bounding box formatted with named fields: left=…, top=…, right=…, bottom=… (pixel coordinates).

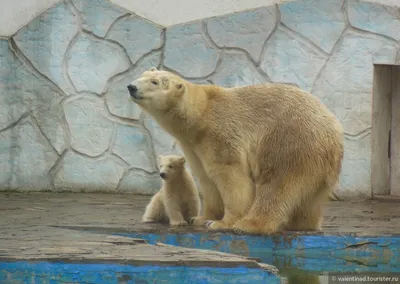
left=118, top=233, right=400, bottom=274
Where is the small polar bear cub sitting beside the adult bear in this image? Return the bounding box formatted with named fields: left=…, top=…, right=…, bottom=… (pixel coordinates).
left=142, top=155, right=200, bottom=226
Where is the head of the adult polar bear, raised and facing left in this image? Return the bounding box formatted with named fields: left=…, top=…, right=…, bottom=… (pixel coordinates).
left=128, top=67, right=186, bottom=114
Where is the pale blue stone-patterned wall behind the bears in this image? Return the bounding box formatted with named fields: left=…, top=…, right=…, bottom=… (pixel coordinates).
left=0, top=0, right=400, bottom=198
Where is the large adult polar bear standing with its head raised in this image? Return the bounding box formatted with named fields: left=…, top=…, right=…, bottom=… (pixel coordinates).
left=128, top=67, right=343, bottom=234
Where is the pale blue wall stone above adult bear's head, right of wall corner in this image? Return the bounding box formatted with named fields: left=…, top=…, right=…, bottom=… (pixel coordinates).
left=164, top=22, right=218, bottom=77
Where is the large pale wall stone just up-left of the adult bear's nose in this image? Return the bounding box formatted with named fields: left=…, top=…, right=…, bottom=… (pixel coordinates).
left=67, top=35, right=130, bottom=94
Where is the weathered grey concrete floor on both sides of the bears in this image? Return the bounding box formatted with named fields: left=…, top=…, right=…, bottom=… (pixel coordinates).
left=0, top=193, right=400, bottom=267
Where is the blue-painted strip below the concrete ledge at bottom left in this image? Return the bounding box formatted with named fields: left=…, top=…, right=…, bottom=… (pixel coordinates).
left=0, top=262, right=280, bottom=284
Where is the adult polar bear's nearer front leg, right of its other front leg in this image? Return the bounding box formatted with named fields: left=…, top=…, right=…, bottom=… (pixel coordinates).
left=204, top=165, right=255, bottom=230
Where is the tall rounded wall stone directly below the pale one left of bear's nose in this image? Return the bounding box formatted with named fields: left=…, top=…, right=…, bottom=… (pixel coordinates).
left=64, top=96, right=114, bottom=157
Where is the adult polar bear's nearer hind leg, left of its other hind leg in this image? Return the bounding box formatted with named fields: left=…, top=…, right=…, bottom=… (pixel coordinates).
left=233, top=181, right=306, bottom=235
